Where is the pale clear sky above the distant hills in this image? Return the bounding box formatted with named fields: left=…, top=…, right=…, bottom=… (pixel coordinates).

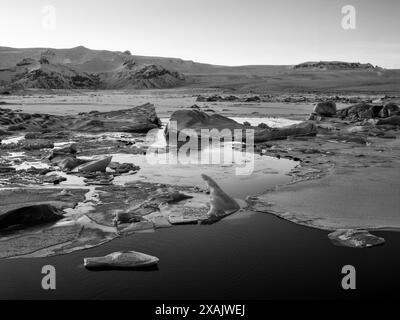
left=0, top=0, right=400, bottom=68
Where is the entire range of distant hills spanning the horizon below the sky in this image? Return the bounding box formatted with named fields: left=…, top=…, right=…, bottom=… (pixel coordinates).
left=0, top=46, right=400, bottom=93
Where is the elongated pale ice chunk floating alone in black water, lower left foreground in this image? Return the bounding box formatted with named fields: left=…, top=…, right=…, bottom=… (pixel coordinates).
left=83, top=251, right=159, bottom=269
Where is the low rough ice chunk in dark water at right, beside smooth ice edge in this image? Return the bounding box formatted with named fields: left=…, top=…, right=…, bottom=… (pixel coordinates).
left=328, top=229, right=385, bottom=248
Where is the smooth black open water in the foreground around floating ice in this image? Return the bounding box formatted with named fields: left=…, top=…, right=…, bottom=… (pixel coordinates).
left=0, top=213, right=400, bottom=299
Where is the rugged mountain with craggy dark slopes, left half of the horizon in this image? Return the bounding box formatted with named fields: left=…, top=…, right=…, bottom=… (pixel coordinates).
left=0, top=47, right=185, bottom=90
